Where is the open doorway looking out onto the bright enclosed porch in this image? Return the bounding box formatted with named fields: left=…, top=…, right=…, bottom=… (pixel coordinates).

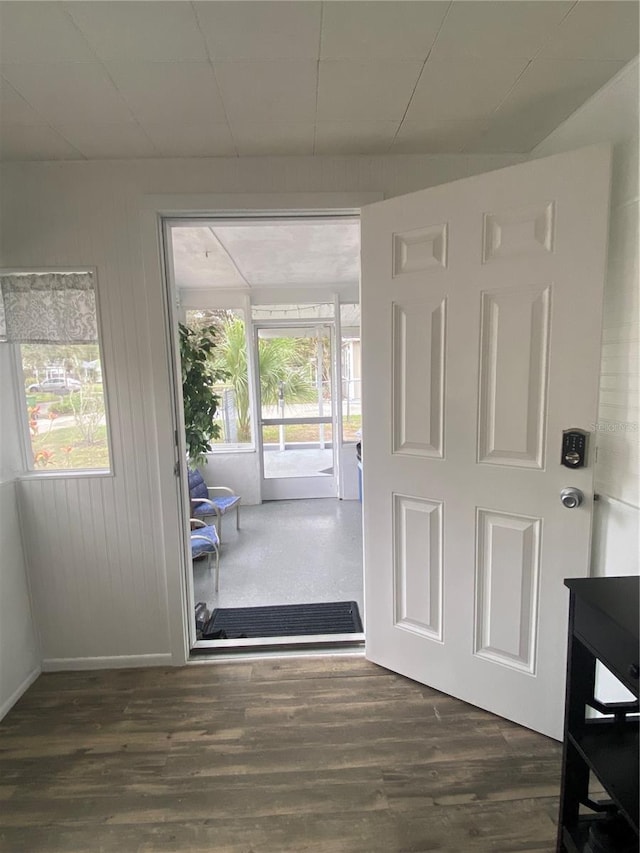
left=164, top=212, right=364, bottom=652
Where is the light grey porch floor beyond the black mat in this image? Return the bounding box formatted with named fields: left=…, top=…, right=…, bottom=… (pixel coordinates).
left=193, top=498, right=364, bottom=616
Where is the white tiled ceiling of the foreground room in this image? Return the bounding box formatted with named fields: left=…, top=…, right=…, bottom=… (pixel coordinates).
left=0, top=0, right=638, bottom=160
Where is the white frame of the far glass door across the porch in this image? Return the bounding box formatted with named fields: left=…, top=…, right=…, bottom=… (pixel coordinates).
left=251, top=314, right=340, bottom=500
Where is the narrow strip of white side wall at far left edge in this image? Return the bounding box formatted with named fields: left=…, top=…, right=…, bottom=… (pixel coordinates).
left=0, top=343, right=40, bottom=719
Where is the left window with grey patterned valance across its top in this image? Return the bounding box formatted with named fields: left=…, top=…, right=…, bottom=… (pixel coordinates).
left=0, top=270, right=110, bottom=472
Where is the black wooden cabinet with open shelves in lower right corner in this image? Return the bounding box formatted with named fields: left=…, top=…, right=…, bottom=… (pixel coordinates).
left=557, top=577, right=640, bottom=853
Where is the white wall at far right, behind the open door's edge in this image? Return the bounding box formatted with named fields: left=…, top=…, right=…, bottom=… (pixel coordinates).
left=533, top=59, right=640, bottom=575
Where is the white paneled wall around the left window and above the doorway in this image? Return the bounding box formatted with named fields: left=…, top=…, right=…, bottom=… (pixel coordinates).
left=0, top=155, right=523, bottom=669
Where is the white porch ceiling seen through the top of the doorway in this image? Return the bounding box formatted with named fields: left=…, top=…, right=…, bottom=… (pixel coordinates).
left=170, top=217, right=360, bottom=292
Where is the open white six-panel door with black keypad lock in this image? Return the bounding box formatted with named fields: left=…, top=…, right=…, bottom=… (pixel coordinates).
left=361, top=147, right=610, bottom=738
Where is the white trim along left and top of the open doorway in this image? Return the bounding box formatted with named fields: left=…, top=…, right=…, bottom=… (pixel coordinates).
left=138, top=191, right=384, bottom=666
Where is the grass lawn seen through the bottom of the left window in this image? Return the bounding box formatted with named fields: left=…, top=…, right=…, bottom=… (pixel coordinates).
left=31, top=426, right=109, bottom=471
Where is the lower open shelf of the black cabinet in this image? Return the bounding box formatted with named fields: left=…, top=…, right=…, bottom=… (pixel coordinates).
left=568, top=720, right=640, bottom=832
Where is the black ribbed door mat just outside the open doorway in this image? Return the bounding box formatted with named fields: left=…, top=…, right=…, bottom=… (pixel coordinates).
left=202, top=601, right=362, bottom=640
